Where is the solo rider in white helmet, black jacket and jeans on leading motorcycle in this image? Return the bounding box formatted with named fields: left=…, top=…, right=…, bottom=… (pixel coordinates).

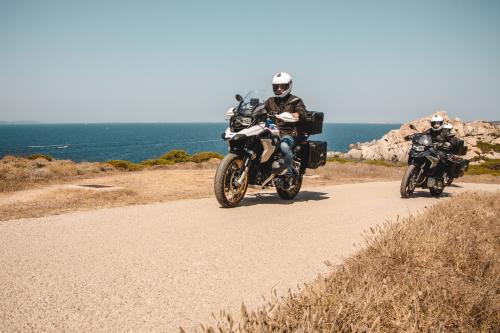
left=265, top=72, right=306, bottom=176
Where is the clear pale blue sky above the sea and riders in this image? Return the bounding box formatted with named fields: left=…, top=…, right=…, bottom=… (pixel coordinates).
left=0, top=0, right=500, bottom=122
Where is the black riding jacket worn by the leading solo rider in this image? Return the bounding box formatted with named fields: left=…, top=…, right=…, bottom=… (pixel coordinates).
left=265, top=94, right=307, bottom=137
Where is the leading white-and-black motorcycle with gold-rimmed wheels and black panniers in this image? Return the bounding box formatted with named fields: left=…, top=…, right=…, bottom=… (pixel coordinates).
left=214, top=92, right=327, bottom=208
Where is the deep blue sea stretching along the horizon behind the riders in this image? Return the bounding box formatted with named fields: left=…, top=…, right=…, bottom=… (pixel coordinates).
left=0, top=123, right=401, bottom=162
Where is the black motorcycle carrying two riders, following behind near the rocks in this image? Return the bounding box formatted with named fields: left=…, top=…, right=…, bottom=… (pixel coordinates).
left=400, top=124, right=469, bottom=198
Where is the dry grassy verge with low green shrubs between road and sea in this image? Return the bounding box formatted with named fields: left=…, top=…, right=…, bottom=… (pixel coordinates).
left=0, top=157, right=500, bottom=220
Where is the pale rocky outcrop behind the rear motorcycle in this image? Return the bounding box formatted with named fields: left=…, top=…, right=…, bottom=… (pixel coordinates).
left=340, top=111, right=500, bottom=161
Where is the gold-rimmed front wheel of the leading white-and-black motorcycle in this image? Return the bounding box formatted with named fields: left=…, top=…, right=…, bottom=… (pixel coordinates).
left=214, top=153, right=248, bottom=208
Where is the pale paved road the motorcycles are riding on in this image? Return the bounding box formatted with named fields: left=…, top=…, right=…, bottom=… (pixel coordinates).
left=0, top=182, right=500, bottom=332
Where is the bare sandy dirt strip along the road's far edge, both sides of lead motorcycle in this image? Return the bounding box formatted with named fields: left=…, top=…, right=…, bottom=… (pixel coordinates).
left=0, top=163, right=500, bottom=221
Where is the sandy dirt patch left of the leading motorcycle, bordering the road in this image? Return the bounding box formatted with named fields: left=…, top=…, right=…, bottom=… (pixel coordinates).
left=0, top=168, right=215, bottom=221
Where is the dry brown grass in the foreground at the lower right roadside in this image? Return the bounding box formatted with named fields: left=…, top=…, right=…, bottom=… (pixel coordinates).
left=203, top=192, right=500, bottom=332
